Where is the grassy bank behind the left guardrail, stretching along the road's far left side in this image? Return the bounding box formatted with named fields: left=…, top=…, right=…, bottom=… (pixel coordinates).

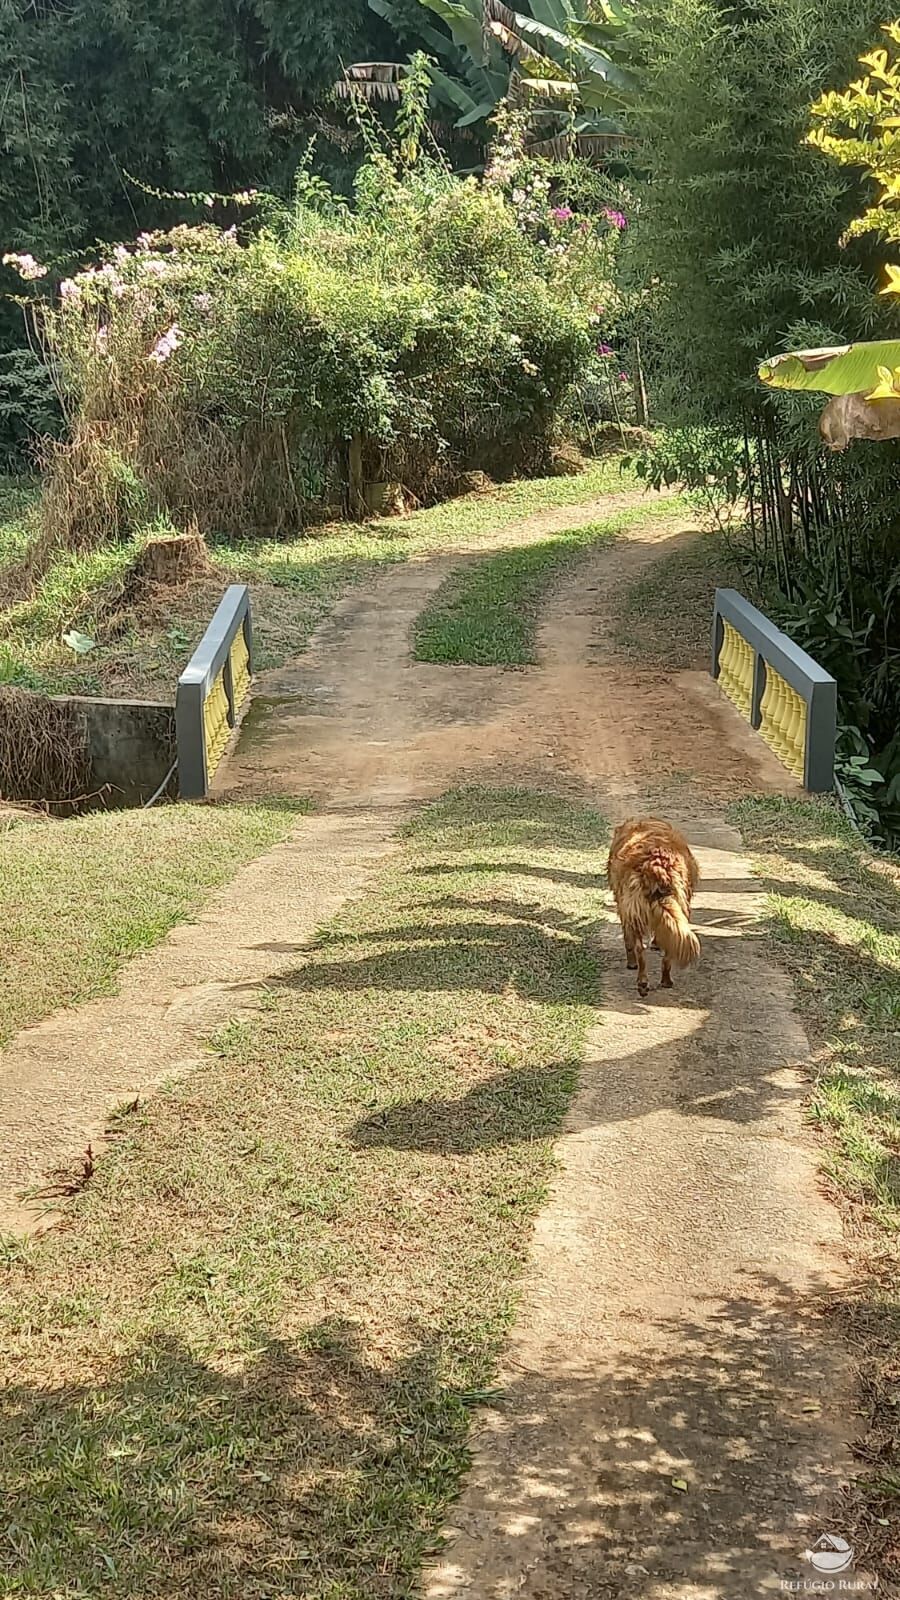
left=0, top=456, right=639, bottom=699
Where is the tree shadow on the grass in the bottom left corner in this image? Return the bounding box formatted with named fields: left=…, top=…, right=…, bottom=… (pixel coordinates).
left=0, top=1322, right=468, bottom=1600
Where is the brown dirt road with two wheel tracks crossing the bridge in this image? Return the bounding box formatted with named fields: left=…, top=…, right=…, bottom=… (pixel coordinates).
left=0, top=492, right=854, bottom=1600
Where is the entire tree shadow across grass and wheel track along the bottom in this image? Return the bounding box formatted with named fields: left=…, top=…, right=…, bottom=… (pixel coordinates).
left=0, top=1286, right=887, bottom=1600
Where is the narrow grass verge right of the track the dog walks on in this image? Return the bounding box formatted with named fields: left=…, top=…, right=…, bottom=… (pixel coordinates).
left=733, top=798, right=900, bottom=1573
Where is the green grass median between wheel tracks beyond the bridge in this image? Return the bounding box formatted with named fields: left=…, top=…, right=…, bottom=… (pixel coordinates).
left=413, top=499, right=679, bottom=667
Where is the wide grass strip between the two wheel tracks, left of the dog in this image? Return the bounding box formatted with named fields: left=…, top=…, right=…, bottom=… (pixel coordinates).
left=0, top=790, right=602, bottom=1600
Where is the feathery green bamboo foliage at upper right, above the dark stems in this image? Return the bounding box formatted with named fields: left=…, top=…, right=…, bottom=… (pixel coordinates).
left=631, top=0, right=881, bottom=421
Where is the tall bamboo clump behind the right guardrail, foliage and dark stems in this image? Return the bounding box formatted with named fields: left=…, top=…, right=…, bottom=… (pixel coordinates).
left=628, top=0, right=900, bottom=837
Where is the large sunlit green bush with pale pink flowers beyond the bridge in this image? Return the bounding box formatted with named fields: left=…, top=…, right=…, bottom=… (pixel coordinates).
left=29, top=154, right=591, bottom=546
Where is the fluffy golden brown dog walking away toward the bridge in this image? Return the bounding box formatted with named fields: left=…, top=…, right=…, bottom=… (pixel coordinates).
left=607, top=816, right=700, bottom=997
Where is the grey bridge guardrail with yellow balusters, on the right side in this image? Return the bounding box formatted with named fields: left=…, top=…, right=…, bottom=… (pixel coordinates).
left=711, top=589, right=838, bottom=794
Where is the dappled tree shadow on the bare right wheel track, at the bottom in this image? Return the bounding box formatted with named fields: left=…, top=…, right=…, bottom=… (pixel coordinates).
left=428, top=1262, right=887, bottom=1600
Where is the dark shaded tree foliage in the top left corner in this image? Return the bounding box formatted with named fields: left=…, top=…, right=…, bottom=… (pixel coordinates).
left=0, top=0, right=392, bottom=254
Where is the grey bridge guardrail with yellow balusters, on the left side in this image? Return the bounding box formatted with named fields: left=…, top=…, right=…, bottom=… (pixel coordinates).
left=175, top=584, right=253, bottom=800
